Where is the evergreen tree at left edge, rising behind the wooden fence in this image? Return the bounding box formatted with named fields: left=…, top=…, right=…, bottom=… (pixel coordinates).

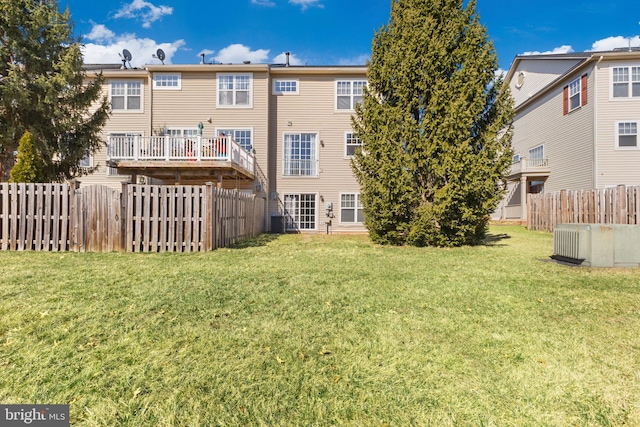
left=0, top=0, right=109, bottom=181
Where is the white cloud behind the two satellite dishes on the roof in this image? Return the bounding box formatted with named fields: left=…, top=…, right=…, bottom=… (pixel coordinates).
left=82, top=24, right=185, bottom=67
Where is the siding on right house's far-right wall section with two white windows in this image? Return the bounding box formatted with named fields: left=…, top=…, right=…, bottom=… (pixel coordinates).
left=596, top=60, right=640, bottom=188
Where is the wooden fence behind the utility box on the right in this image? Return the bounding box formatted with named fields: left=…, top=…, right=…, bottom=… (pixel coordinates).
left=527, top=185, right=640, bottom=231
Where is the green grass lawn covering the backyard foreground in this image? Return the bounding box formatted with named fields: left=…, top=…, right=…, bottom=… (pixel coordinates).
left=0, top=226, right=640, bottom=427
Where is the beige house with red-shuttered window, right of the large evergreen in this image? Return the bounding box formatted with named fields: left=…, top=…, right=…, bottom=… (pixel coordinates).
left=496, top=48, right=640, bottom=219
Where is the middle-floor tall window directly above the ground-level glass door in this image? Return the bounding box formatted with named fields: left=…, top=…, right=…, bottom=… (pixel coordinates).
left=283, top=133, right=318, bottom=177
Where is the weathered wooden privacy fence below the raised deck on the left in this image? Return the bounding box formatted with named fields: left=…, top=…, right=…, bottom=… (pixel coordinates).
left=0, top=183, right=266, bottom=252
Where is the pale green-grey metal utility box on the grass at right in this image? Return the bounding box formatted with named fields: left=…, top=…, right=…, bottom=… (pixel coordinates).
left=552, top=224, right=640, bottom=267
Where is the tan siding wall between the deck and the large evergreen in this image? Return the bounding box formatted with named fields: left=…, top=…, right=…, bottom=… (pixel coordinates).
left=269, top=69, right=366, bottom=231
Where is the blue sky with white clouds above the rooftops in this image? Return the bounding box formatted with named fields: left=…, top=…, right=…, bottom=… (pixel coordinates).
left=66, top=0, right=640, bottom=69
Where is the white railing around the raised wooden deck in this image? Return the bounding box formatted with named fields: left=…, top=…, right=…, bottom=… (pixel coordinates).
left=107, top=136, right=255, bottom=174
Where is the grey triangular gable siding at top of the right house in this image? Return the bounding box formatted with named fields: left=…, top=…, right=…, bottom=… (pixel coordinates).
left=509, top=58, right=582, bottom=107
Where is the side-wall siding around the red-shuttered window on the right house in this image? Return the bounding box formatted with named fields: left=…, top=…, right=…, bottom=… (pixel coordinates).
left=512, top=70, right=595, bottom=192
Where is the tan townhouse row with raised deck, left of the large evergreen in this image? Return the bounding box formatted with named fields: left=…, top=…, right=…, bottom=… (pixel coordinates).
left=81, top=63, right=367, bottom=232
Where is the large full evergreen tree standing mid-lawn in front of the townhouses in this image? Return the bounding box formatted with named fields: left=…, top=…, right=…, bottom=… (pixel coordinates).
left=353, top=0, right=513, bottom=246
